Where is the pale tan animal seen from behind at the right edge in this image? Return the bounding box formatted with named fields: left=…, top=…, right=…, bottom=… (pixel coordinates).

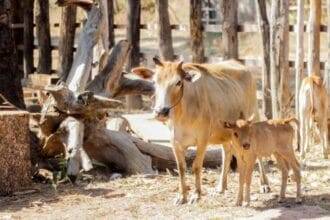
left=299, top=75, right=330, bottom=159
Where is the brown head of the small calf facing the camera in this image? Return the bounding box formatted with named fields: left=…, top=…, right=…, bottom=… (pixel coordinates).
left=224, top=116, right=254, bottom=150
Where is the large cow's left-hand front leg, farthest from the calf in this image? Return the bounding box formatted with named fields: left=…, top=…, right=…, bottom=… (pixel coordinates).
left=174, top=145, right=188, bottom=205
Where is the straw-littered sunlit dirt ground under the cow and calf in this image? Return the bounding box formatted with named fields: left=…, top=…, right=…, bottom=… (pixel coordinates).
left=0, top=144, right=330, bottom=219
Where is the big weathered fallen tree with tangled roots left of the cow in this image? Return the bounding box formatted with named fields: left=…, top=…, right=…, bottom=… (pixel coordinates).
left=34, top=0, right=221, bottom=181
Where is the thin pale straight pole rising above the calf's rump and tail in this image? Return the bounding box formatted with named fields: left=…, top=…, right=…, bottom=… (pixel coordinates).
left=295, top=0, right=306, bottom=117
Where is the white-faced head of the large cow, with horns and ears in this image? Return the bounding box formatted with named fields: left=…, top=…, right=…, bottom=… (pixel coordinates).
left=132, top=57, right=201, bottom=121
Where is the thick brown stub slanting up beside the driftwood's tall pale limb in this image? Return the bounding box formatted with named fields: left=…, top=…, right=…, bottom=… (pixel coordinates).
left=87, top=40, right=130, bottom=97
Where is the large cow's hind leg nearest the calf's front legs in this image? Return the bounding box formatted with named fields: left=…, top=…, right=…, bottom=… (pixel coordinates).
left=216, top=144, right=233, bottom=193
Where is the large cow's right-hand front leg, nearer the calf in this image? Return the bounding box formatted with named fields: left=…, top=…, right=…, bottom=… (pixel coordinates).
left=189, top=144, right=206, bottom=204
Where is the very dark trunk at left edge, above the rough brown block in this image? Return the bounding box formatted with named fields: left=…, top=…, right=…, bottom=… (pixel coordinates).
left=0, top=0, right=25, bottom=109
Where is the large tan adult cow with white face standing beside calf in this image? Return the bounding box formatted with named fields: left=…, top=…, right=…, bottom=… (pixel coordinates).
left=132, top=58, right=269, bottom=204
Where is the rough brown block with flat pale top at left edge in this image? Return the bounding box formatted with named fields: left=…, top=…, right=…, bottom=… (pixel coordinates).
left=0, top=111, right=31, bottom=195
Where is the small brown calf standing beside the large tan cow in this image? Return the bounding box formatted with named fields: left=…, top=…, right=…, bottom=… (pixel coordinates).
left=225, top=118, right=301, bottom=205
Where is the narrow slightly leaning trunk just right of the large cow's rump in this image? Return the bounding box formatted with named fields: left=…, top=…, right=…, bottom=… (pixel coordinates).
left=257, top=0, right=273, bottom=119
